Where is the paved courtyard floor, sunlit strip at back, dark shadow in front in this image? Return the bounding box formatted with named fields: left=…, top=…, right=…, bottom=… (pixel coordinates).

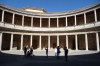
left=0, top=51, right=100, bottom=66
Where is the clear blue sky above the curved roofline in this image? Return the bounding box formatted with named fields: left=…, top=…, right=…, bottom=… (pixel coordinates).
left=0, top=0, right=100, bottom=12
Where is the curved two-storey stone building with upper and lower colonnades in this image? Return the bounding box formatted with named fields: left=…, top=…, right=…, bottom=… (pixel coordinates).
left=0, top=3, right=100, bottom=51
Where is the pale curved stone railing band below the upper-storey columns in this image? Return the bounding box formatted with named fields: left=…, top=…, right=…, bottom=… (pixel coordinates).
left=0, top=21, right=100, bottom=31
